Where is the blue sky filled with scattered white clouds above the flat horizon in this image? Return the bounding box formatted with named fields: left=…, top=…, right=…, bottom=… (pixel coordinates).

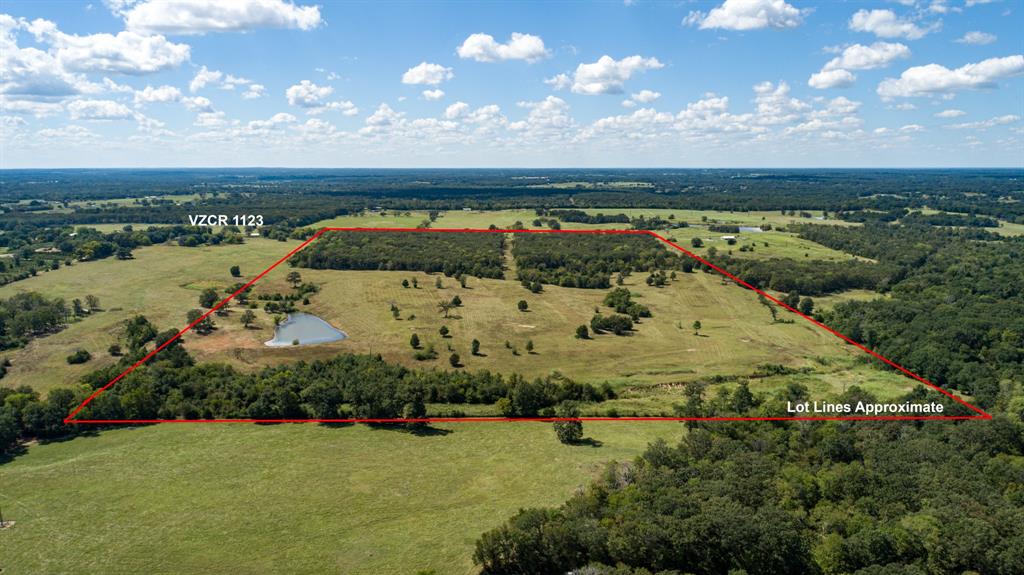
left=0, top=0, right=1024, bottom=169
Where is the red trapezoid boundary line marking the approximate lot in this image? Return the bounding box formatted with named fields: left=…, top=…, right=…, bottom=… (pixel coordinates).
left=63, top=227, right=992, bottom=425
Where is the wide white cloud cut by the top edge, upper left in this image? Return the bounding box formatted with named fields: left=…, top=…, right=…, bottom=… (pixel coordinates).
left=119, top=0, right=324, bottom=34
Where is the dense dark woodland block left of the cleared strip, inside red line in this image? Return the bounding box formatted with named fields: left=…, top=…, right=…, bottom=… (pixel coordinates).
left=289, top=232, right=504, bottom=278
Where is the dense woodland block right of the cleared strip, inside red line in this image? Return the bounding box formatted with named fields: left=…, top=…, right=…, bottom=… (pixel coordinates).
left=512, top=233, right=681, bottom=290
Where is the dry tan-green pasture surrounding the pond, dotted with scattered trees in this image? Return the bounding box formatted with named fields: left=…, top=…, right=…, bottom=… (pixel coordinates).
left=0, top=226, right=909, bottom=405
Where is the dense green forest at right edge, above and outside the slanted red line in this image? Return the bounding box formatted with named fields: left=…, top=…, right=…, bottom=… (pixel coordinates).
left=800, top=219, right=1024, bottom=406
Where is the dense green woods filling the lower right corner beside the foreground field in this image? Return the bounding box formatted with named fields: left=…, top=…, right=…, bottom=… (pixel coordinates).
left=473, top=386, right=1024, bottom=575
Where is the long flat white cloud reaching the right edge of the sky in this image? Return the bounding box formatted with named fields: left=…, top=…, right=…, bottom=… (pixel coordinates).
left=878, top=54, right=1024, bottom=99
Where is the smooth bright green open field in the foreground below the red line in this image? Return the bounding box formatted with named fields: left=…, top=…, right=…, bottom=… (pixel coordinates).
left=0, top=422, right=683, bottom=575
